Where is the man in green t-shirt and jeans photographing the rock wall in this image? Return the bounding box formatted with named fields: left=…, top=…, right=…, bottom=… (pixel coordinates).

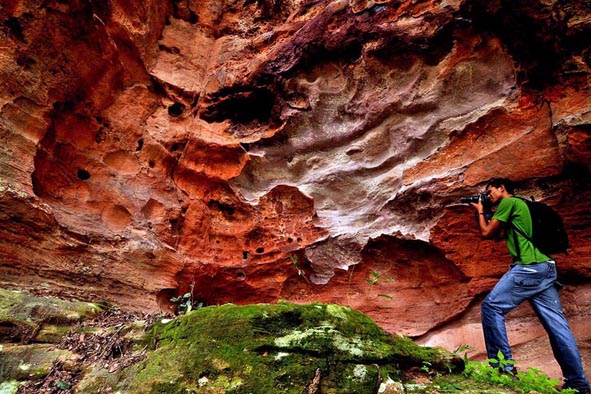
left=472, top=178, right=590, bottom=393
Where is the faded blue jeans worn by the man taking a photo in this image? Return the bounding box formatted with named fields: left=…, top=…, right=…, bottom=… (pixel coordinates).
left=481, top=261, right=589, bottom=390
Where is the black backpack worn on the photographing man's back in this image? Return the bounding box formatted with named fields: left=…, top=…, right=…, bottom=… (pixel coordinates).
left=512, top=197, right=570, bottom=255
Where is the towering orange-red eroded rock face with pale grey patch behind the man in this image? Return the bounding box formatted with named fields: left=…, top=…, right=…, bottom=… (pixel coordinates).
left=0, top=0, right=591, bottom=375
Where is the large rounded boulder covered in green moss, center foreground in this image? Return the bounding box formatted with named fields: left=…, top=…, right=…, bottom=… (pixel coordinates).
left=107, top=303, right=463, bottom=394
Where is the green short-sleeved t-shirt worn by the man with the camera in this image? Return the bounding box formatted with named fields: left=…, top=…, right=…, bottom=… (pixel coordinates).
left=493, top=197, right=551, bottom=264
